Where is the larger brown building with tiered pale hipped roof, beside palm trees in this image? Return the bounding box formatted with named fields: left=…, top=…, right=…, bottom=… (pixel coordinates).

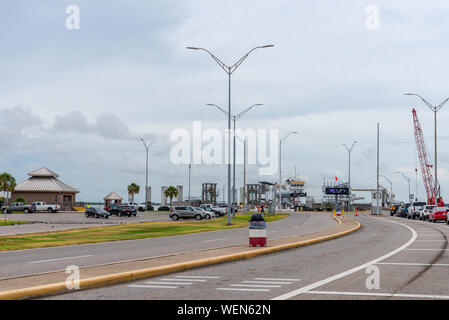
left=11, top=168, right=79, bottom=210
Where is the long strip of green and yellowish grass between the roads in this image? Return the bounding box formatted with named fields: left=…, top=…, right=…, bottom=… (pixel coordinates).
left=0, top=213, right=288, bottom=251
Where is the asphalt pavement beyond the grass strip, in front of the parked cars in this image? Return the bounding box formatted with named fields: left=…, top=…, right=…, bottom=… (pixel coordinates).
left=0, top=212, right=171, bottom=236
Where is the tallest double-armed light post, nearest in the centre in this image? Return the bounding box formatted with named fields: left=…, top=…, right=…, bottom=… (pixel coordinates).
left=187, top=44, right=274, bottom=225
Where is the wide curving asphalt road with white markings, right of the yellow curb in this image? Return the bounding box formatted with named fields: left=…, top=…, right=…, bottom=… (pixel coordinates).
left=47, top=216, right=449, bottom=300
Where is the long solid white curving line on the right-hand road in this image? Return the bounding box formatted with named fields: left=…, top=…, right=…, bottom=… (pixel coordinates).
left=271, top=218, right=418, bottom=300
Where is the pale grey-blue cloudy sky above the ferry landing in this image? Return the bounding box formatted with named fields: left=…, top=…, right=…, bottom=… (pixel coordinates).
left=0, top=0, right=449, bottom=201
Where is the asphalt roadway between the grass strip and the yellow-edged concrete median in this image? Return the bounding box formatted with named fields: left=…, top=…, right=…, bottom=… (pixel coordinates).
left=0, top=213, right=336, bottom=278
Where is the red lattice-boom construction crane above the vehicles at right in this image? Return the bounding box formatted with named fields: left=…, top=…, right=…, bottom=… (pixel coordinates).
left=412, top=109, right=444, bottom=206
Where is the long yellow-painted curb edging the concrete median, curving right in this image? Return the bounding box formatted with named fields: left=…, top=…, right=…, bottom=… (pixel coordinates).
left=0, top=219, right=361, bottom=300
